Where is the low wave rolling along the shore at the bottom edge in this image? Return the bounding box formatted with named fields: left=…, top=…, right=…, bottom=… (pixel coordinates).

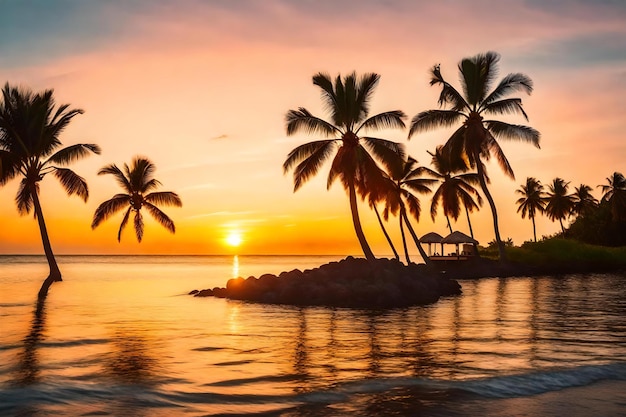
left=0, top=362, right=626, bottom=415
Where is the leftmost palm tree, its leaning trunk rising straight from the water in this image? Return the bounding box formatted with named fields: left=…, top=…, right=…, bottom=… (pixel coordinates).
left=0, top=83, right=100, bottom=299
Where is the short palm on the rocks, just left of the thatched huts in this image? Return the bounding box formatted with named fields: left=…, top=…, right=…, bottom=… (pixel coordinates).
left=383, top=157, right=436, bottom=264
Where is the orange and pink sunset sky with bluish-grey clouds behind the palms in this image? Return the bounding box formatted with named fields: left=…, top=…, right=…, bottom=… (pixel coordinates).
left=0, top=0, right=626, bottom=256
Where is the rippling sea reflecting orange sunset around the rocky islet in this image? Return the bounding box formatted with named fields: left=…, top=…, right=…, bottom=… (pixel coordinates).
left=0, top=256, right=626, bottom=417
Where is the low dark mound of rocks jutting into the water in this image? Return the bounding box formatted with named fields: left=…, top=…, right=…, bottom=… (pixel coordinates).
left=189, top=257, right=461, bottom=308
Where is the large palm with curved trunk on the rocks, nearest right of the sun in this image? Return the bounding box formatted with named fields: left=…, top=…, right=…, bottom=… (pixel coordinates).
left=283, top=73, right=405, bottom=260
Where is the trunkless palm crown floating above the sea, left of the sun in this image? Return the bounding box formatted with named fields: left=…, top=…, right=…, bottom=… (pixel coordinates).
left=91, top=156, right=183, bottom=242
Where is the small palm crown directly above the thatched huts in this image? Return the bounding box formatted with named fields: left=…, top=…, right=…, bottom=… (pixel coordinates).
left=418, top=146, right=483, bottom=238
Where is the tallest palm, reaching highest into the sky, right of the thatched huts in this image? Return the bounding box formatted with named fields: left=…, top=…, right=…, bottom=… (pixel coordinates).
left=409, top=52, right=539, bottom=260
